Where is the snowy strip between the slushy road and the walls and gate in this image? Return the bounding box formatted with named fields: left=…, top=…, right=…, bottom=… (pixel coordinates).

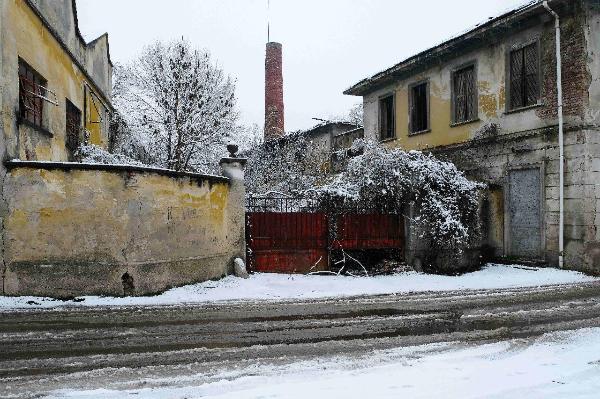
left=0, top=265, right=598, bottom=310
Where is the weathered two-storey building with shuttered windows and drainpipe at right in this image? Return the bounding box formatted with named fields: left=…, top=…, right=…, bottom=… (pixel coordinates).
left=345, top=0, right=600, bottom=273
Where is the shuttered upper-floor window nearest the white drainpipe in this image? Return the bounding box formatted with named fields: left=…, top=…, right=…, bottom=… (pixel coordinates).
left=510, top=43, right=540, bottom=109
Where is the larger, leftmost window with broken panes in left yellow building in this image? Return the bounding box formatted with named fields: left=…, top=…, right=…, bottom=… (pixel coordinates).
left=19, top=60, right=46, bottom=127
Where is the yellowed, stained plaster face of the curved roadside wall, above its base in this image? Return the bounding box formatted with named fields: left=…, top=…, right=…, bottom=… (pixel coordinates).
left=6, top=168, right=232, bottom=263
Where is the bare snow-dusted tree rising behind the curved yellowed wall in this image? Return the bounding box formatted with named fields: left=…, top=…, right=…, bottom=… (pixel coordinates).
left=115, top=39, right=238, bottom=171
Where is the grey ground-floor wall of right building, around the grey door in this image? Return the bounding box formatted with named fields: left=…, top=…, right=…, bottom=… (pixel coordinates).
left=434, top=128, right=600, bottom=273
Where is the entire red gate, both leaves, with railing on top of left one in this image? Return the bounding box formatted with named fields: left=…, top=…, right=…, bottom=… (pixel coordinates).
left=246, top=197, right=404, bottom=273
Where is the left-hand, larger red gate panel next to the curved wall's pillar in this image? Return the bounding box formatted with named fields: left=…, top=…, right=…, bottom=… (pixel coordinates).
left=246, top=212, right=328, bottom=273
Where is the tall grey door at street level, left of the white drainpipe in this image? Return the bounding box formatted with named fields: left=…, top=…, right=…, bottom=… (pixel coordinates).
left=508, top=169, right=542, bottom=259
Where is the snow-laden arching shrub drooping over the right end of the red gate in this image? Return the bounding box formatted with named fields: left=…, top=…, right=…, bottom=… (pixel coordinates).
left=306, top=140, right=484, bottom=253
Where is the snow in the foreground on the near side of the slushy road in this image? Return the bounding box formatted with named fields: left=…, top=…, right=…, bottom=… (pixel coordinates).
left=48, top=328, right=600, bottom=399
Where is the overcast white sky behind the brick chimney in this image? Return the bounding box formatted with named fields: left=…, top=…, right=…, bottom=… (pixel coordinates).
left=77, top=0, right=525, bottom=131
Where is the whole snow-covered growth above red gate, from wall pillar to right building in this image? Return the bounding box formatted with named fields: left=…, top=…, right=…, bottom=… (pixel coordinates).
left=247, top=137, right=484, bottom=271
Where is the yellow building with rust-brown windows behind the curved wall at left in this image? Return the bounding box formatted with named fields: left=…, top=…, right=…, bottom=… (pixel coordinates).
left=0, top=0, right=112, bottom=161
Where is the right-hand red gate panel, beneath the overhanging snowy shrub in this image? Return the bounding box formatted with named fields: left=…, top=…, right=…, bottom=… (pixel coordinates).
left=334, top=214, right=404, bottom=250
